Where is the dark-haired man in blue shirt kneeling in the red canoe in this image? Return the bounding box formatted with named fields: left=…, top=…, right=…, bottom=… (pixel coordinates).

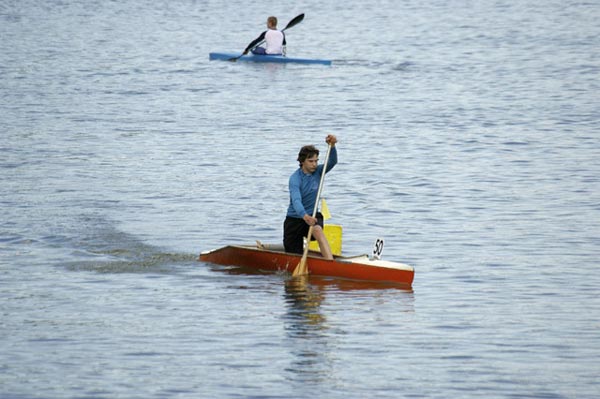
left=283, top=134, right=337, bottom=259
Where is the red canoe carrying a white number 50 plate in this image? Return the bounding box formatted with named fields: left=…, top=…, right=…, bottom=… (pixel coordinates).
left=199, top=245, right=415, bottom=287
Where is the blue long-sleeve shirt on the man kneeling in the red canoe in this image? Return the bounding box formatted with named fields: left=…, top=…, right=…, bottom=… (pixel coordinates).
left=287, top=146, right=337, bottom=219
